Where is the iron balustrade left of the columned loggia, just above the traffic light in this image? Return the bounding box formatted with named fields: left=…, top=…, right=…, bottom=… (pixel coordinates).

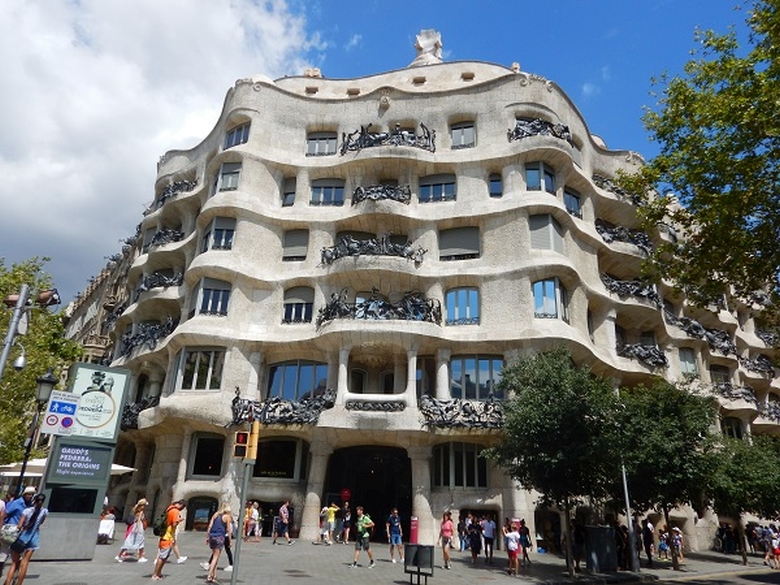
left=231, top=388, right=336, bottom=425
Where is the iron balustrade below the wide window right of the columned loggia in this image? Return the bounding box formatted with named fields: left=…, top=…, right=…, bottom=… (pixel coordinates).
left=418, top=393, right=504, bottom=429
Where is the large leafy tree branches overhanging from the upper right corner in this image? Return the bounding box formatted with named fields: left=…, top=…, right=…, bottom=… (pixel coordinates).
left=623, top=0, right=780, bottom=316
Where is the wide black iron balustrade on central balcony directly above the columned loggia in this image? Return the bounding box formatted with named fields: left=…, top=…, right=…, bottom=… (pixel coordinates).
left=317, top=288, right=441, bottom=327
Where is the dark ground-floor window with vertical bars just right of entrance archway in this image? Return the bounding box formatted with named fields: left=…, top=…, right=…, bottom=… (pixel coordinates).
left=433, top=443, right=487, bottom=489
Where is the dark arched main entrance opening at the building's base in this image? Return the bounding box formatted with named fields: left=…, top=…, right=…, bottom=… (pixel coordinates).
left=323, top=445, right=412, bottom=542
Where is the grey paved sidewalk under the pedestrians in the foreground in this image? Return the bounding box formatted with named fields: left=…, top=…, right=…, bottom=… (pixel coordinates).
left=3, top=527, right=771, bottom=585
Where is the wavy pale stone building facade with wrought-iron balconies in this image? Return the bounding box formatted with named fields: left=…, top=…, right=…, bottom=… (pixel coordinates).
left=68, top=36, right=780, bottom=547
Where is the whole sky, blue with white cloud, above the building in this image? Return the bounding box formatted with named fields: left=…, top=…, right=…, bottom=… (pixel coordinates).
left=0, top=0, right=747, bottom=306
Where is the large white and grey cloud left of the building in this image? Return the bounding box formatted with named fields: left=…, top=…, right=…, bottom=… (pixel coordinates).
left=0, top=0, right=310, bottom=301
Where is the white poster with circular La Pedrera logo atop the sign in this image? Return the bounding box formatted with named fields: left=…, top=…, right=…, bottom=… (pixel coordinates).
left=70, top=364, right=130, bottom=441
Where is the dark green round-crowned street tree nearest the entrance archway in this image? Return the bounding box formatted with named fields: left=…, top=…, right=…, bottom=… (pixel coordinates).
left=486, top=348, right=620, bottom=575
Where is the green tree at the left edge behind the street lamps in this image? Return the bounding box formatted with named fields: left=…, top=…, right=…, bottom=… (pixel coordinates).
left=0, top=258, right=81, bottom=463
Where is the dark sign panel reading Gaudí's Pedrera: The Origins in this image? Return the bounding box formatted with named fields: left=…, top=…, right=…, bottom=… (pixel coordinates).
left=47, top=441, right=112, bottom=484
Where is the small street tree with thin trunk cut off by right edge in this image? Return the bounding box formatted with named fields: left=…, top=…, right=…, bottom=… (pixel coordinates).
left=712, top=435, right=780, bottom=565
